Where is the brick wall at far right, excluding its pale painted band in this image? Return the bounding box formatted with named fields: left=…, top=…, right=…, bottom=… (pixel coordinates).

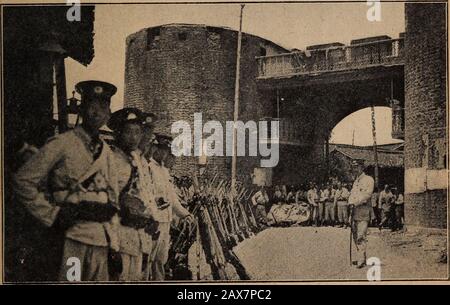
left=405, top=3, right=447, bottom=227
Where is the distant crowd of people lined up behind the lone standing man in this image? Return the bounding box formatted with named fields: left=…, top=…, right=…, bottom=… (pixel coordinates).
left=252, top=178, right=404, bottom=231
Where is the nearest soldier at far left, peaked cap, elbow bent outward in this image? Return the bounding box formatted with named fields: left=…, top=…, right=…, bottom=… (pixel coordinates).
left=14, top=81, right=122, bottom=281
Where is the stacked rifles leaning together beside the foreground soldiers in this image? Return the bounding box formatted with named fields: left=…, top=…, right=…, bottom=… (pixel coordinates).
left=169, top=175, right=258, bottom=280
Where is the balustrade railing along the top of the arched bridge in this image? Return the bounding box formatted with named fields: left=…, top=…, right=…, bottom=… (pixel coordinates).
left=256, top=38, right=404, bottom=78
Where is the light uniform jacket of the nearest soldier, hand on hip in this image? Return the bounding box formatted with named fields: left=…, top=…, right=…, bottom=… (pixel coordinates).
left=14, top=127, right=118, bottom=246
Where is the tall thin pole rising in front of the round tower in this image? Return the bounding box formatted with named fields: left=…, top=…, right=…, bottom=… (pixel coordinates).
left=231, top=4, right=245, bottom=191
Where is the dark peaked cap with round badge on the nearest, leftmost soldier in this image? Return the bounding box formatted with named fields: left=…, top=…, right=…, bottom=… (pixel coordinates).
left=75, top=80, right=117, bottom=103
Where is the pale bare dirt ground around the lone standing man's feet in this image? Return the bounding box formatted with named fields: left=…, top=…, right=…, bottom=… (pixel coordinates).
left=230, top=227, right=448, bottom=281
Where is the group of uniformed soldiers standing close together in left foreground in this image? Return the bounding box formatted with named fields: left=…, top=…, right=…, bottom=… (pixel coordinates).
left=14, top=81, right=193, bottom=281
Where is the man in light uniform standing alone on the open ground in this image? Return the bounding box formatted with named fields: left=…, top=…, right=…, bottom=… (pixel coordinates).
left=348, top=161, right=375, bottom=268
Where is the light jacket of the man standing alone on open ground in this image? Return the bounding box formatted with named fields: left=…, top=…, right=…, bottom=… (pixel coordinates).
left=348, top=173, right=375, bottom=221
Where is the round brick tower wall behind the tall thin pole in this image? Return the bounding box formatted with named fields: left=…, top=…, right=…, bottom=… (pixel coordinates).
left=124, top=24, right=286, bottom=182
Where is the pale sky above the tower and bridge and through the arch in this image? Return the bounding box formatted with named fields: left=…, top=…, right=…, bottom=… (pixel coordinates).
left=66, top=2, right=405, bottom=145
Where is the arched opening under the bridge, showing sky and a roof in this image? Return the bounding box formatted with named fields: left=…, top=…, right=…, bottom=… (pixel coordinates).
left=325, top=107, right=404, bottom=192
